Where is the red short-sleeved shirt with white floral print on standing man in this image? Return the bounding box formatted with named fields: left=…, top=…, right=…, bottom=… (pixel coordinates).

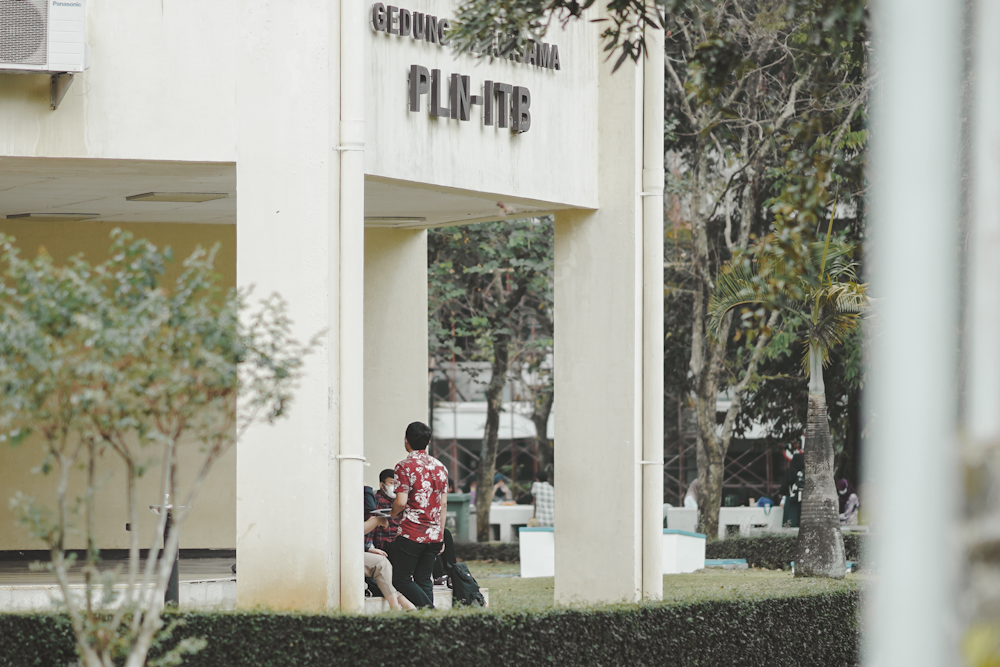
left=395, top=449, right=448, bottom=542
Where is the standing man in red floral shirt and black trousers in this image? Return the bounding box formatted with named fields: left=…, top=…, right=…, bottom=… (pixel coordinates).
left=389, top=422, right=448, bottom=607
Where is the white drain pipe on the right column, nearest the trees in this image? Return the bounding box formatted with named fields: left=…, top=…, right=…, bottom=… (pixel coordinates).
left=641, top=27, right=664, bottom=600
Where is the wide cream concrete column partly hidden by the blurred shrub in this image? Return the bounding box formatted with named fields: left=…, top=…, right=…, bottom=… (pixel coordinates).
left=236, top=0, right=344, bottom=610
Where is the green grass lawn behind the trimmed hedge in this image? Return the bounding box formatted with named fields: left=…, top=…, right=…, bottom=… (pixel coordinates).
left=467, top=561, right=865, bottom=611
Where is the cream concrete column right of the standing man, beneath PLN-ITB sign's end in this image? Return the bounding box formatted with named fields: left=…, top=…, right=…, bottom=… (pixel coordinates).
left=555, top=43, right=644, bottom=604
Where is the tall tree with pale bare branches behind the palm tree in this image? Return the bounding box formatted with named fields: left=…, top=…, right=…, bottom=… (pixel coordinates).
left=665, top=0, right=868, bottom=534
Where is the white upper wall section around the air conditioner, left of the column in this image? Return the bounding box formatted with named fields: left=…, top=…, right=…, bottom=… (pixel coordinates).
left=0, top=0, right=237, bottom=162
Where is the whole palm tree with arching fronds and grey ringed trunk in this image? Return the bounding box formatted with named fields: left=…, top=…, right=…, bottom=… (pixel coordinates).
left=711, top=216, right=868, bottom=579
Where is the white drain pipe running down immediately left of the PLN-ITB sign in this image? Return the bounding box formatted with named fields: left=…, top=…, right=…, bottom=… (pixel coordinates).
left=340, top=0, right=365, bottom=613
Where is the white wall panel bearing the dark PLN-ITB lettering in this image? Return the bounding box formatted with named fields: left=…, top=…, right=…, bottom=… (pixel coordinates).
left=359, top=0, right=600, bottom=208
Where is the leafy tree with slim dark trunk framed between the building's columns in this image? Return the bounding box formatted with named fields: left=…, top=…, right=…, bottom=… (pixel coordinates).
left=427, top=218, right=553, bottom=542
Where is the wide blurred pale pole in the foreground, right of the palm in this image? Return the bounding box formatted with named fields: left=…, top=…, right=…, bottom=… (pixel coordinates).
left=865, top=0, right=964, bottom=667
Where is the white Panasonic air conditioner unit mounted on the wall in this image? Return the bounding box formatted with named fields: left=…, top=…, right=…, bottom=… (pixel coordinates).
left=0, top=0, right=90, bottom=73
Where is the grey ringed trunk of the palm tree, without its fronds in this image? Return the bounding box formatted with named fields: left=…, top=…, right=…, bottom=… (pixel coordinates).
left=795, top=343, right=846, bottom=579
